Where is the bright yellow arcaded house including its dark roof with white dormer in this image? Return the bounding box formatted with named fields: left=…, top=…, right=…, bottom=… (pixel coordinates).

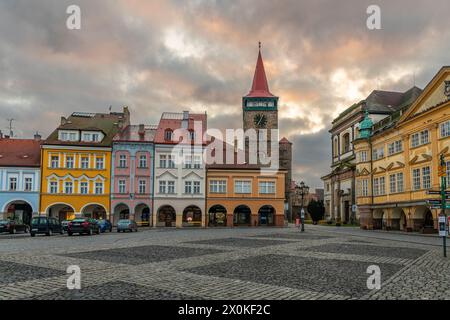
left=40, top=107, right=130, bottom=220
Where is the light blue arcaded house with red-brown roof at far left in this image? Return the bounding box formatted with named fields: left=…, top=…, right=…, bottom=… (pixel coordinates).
left=0, top=132, right=41, bottom=224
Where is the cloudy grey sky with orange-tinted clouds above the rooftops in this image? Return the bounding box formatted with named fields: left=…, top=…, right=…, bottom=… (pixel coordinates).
left=0, top=0, right=450, bottom=188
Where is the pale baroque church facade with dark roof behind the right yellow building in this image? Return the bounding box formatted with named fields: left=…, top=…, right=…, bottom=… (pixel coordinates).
left=322, top=87, right=421, bottom=224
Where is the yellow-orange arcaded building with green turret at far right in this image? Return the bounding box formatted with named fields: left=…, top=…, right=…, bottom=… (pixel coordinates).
left=353, top=67, right=450, bottom=232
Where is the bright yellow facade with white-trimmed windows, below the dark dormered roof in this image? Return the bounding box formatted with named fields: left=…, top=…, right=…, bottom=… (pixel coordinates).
left=40, top=145, right=111, bottom=220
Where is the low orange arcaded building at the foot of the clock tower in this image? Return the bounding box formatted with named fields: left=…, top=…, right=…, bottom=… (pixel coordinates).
left=206, top=164, right=286, bottom=227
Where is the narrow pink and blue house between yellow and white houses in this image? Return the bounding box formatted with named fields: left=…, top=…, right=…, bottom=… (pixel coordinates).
left=111, top=124, right=157, bottom=226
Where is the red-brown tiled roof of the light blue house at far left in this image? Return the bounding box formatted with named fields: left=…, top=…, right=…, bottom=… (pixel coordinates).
left=0, top=139, right=42, bottom=167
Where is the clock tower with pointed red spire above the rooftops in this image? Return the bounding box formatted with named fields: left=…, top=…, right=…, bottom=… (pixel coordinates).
left=242, top=43, right=278, bottom=160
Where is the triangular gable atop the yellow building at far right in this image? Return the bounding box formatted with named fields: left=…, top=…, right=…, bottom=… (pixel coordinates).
left=399, top=67, right=450, bottom=122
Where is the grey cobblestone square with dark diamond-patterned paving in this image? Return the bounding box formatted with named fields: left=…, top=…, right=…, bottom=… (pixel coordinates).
left=0, top=226, right=450, bottom=300
